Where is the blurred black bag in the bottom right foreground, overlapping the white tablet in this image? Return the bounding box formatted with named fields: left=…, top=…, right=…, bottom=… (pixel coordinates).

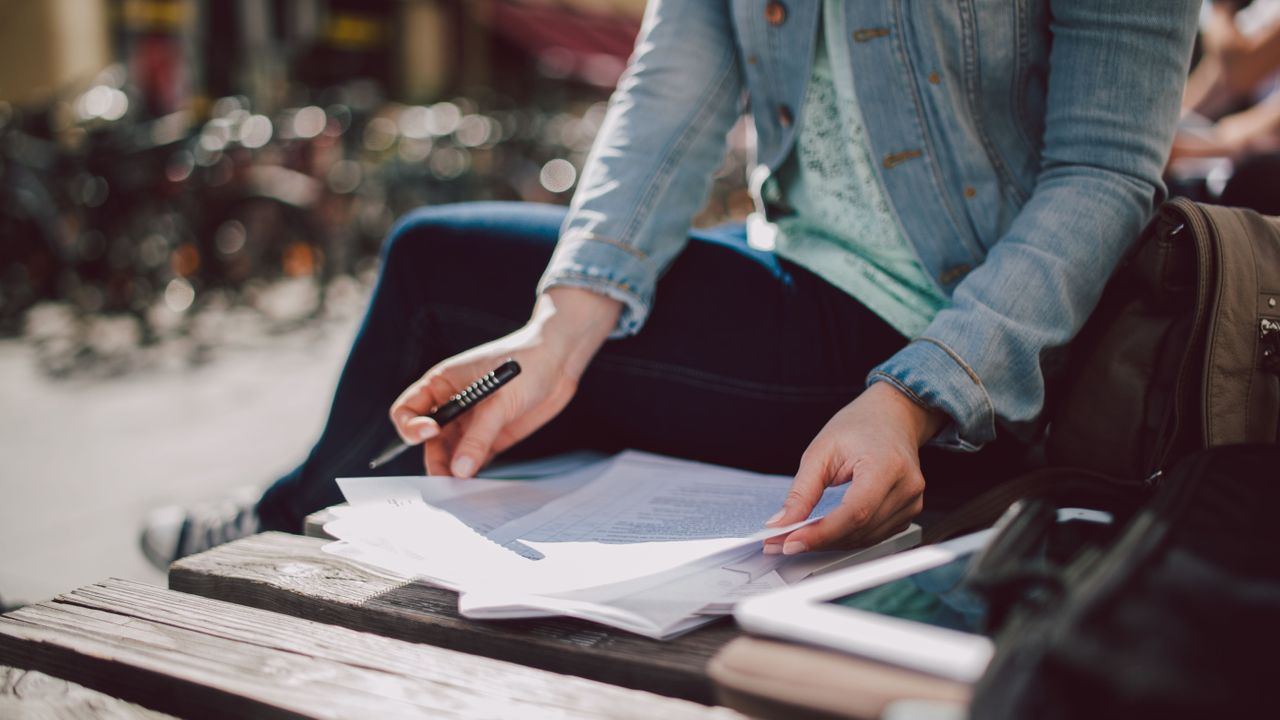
left=970, top=446, right=1280, bottom=720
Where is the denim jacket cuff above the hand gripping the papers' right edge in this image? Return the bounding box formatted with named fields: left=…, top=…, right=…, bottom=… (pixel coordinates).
left=867, top=337, right=996, bottom=452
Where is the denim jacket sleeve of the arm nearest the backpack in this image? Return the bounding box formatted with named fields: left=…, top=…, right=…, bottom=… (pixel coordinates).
left=868, top=0, right=1199, bottom=450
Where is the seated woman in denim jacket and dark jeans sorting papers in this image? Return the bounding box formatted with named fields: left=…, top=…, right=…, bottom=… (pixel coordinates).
left=140, top=0, right=1198, bottom=559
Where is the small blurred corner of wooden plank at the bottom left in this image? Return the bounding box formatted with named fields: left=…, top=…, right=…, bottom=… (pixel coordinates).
left=0, top=666, right=173, bottom=720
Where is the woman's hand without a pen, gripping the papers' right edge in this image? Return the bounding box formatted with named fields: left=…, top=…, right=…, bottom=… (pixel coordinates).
left=764, top=383, right=946, bottom=555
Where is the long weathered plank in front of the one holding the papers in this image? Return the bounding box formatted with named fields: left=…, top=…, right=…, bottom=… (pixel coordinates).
left=0, top=580, right=740, bottom=720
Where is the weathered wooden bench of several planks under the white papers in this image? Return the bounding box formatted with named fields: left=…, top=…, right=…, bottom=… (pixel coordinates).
left=0, top=486, right=783, bottom=719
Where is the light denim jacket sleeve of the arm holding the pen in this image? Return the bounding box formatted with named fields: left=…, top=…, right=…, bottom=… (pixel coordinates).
left=539, top=0, right=742, bottom=337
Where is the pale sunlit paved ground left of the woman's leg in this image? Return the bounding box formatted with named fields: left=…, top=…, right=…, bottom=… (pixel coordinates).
left=0, top=294, right=366, bottom=603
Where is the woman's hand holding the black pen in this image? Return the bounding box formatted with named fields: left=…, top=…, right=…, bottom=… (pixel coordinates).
left=390, top=287, right=622, bottom=478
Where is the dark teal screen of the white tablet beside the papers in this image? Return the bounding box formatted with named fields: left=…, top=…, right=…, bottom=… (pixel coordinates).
left=828, top=552, right=987, bottom=633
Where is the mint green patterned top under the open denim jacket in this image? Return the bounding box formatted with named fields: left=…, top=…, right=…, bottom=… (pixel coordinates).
left=771, top=0, right=947, bottom=338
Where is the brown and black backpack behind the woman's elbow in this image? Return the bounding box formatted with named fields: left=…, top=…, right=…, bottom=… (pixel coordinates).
left=1046, top=199, right=1280, bottom=479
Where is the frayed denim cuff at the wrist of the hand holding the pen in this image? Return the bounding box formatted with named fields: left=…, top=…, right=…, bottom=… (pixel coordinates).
left=538, top=233, right=653, bottom=340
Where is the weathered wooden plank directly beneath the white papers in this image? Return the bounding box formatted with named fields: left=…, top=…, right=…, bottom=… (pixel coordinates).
left=169, top=533, right=741, bottom=705
